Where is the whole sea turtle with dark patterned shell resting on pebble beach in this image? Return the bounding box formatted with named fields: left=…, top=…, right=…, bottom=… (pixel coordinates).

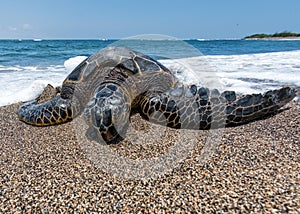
left=18, top=47, right=296, bottom=143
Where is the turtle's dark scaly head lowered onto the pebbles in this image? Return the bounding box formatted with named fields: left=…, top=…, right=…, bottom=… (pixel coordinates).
left=84, top=84, right=131, bottom=144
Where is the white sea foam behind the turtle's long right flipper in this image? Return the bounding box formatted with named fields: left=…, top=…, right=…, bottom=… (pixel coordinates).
left=161, top=51, right=300, bottom=94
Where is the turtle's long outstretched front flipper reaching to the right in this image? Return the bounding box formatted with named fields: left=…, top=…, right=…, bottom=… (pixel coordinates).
left=139, top=85, right=296, bottom=129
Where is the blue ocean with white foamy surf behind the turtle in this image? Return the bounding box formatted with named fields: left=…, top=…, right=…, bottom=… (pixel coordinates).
left=0, top=39, right=300, bottom=106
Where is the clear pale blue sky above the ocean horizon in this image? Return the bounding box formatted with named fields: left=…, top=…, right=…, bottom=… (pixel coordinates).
left=0, top=0, right=300, bottom=39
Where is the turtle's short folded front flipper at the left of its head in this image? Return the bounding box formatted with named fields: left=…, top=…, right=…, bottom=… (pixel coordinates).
left=18, top=96, right=76, bottom=126
